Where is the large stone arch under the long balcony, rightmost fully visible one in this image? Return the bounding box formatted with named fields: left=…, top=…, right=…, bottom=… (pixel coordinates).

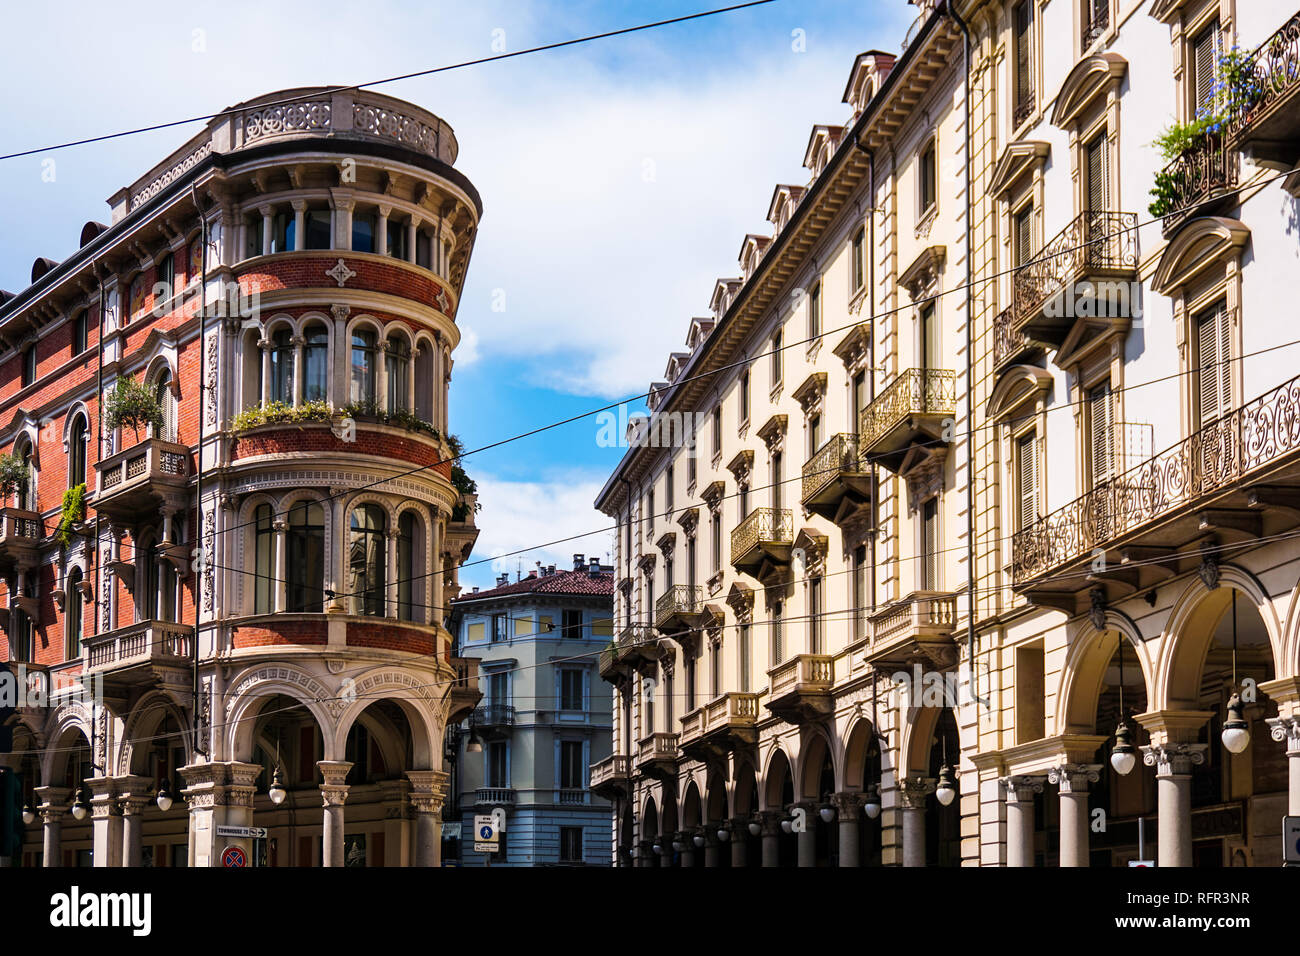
left=1149, top=564, right=1284, bottom=710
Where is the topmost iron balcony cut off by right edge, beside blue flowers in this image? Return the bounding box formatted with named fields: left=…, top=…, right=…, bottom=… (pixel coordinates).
left=1236, top=13, right=1300, bottom=172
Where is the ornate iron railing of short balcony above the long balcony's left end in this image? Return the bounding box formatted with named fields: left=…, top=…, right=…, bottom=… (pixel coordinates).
left=1011, top=209, right=1138, bottom=323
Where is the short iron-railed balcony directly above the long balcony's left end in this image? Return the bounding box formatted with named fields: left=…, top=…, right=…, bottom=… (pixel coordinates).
left=1011, top=211, right=1138, bottom=349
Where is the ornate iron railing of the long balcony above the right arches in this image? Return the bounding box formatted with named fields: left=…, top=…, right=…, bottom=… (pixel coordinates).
left=1011, top=366, right=1300, bottom=584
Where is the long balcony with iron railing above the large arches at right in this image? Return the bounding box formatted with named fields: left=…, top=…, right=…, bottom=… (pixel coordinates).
left=1011, top=376, right=1300, bottom=614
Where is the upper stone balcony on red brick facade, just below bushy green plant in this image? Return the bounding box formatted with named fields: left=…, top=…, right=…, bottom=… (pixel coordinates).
left=90, top=438, right=190, bottom=523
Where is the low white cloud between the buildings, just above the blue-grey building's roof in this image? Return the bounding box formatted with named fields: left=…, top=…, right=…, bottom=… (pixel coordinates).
left=460, top=473, right=614, bottom=591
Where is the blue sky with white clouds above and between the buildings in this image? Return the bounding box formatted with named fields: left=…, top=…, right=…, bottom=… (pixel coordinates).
left=0, top=0, right=915, bottom=588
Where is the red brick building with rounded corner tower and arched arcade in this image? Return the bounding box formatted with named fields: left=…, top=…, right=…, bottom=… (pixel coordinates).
left=0, top=87, right=481, bottom=866
